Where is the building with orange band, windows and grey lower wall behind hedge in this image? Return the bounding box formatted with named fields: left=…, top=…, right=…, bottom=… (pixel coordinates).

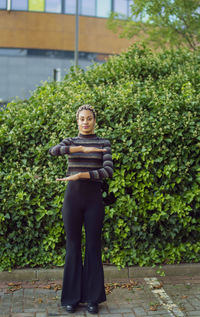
left=0, top=0, right=136, bottom=102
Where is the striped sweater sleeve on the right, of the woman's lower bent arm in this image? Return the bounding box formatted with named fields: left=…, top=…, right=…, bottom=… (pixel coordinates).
left=89, top=140, right=113, bottom=180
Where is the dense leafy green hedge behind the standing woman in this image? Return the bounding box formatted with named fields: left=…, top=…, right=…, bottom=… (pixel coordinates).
left=0, top=46, right=200, bottom=270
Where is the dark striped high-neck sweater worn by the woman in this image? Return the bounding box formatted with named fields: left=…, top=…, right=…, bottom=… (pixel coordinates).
left=49, top=133, right=113, bottom=182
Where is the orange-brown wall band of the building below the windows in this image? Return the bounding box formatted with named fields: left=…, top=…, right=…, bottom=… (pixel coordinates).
left=0, top=11, right=134, bottom=54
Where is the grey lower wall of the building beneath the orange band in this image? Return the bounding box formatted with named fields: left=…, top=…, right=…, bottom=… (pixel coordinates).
left=0, top=56, right=100, bottom=101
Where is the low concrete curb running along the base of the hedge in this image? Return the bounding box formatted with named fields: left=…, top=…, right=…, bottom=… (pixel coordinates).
left=0, top=263, right=200, bottom=282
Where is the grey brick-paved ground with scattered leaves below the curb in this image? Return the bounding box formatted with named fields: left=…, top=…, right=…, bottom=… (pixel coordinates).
left=0, top=275, right=200, bottom=317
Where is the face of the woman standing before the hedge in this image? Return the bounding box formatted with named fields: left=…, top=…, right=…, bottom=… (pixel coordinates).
left=77, top=110, right=96, bottom=134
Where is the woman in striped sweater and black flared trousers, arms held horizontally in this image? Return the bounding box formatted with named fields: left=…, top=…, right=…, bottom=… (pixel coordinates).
left=49, top=105, right=113, bottom=314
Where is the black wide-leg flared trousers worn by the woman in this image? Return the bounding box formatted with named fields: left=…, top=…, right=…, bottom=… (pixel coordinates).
left=61, top=180, right=106, bottom=306
